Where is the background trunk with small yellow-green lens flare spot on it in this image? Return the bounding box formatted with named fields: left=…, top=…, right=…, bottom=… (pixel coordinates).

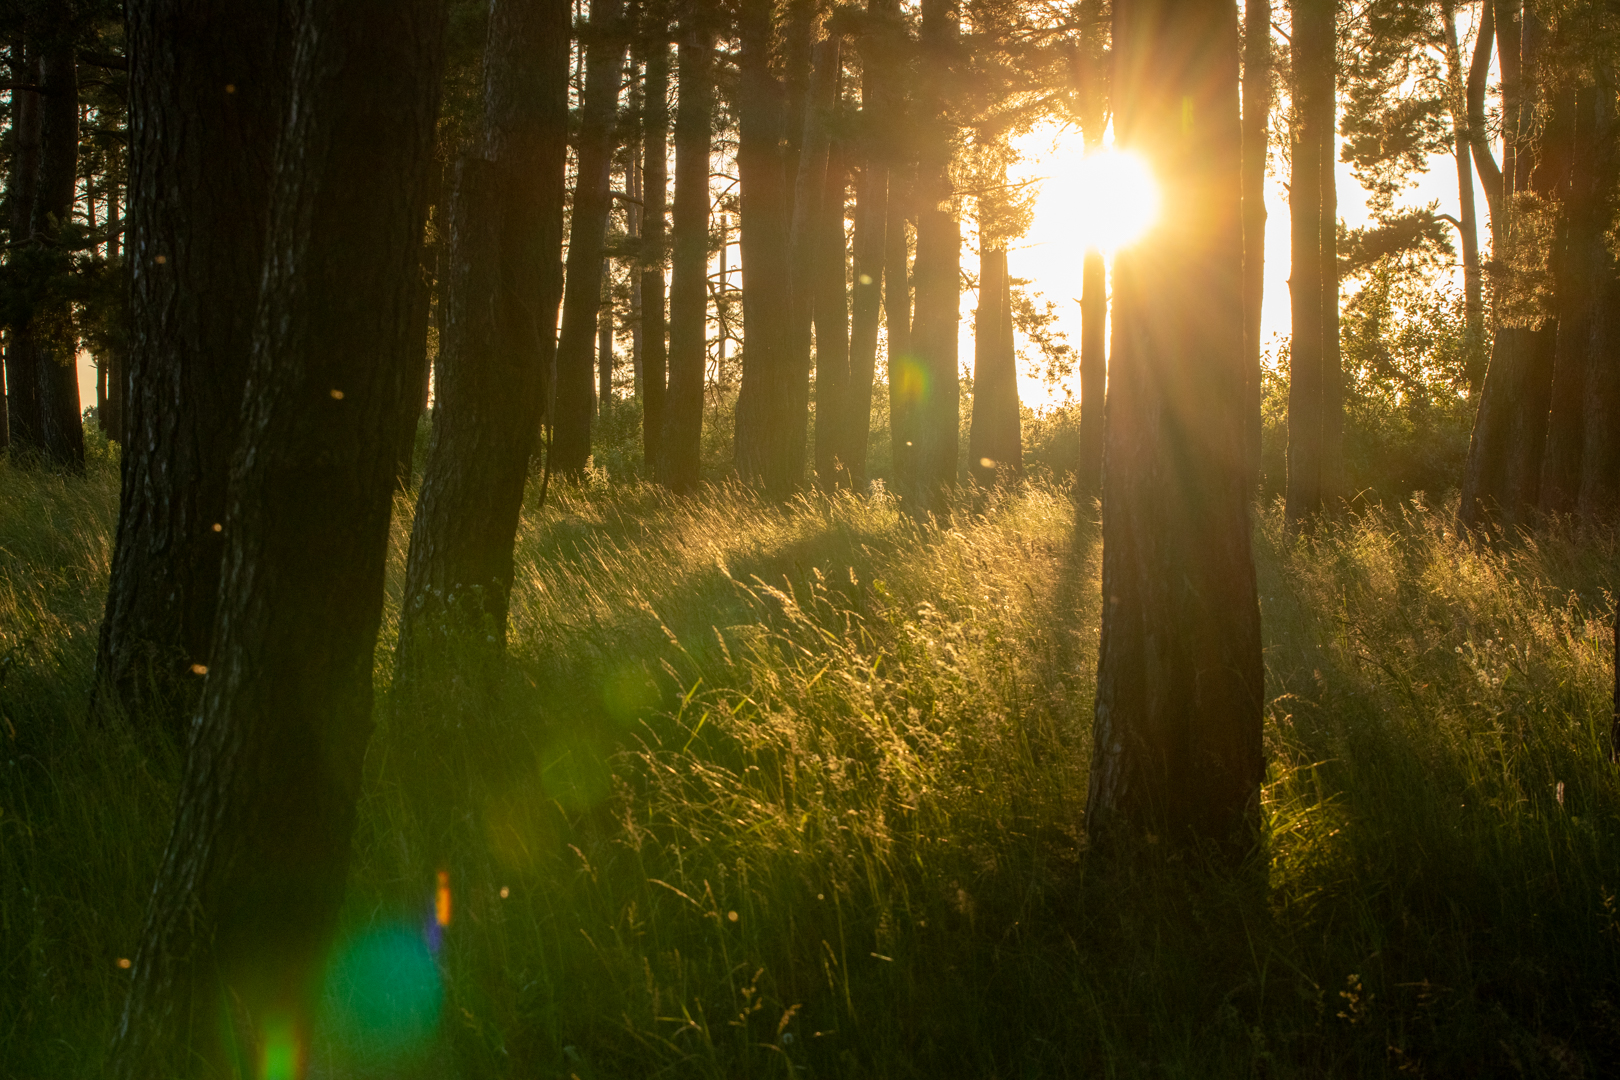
left=907, top=0, right=962, bottom=510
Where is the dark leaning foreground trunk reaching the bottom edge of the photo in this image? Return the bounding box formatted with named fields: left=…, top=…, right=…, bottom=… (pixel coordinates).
left=107, top=0, right=444, bottom=1080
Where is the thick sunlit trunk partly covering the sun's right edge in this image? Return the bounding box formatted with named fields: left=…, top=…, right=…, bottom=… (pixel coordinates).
left=1085, top=0, right=1265, bottom=852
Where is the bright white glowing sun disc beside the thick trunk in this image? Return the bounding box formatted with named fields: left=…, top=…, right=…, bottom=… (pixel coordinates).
left=1040, top=149, right=1158, bottom=254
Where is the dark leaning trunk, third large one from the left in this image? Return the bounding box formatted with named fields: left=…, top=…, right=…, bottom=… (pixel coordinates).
left=394, top=0, right=569, bottom=712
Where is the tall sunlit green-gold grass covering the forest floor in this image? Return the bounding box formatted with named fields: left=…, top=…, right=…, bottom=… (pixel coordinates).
left=0, top=443, right=1620, bottom=1080
